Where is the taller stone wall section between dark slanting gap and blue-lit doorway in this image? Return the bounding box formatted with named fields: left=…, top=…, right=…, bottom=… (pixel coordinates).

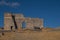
left=14, top=14, right=24, bottom=30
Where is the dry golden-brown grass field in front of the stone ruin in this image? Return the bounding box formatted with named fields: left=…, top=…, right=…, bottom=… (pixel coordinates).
left=0, top=28, right=60, bottom=40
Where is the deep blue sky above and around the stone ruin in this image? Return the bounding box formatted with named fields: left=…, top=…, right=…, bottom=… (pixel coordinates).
left=0, top=0, right=60, bottom=28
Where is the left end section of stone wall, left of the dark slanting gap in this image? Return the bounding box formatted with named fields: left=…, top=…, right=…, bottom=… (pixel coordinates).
left=4, top=13, right=14, bottom=30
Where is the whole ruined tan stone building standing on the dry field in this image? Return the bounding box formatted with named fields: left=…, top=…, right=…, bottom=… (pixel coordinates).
left=4, top=13, right=43, bottom=30
